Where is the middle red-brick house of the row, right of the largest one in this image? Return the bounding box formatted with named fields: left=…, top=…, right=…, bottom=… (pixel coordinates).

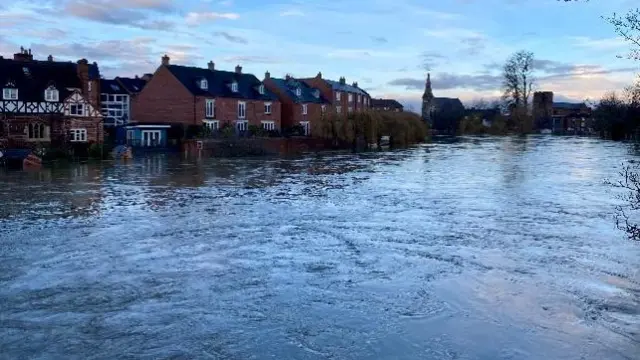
left=263, top=72, right=331, bottom=135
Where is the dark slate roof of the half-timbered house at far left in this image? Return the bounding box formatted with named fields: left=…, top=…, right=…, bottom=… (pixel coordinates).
left=0, top=59, right=83, bottom=102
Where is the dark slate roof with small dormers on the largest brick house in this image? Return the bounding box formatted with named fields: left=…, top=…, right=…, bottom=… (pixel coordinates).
left=166, top=65, right=278, bottom=100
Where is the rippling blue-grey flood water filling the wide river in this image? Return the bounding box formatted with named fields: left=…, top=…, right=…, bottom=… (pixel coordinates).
left=0, top=136, right=640, bottom=359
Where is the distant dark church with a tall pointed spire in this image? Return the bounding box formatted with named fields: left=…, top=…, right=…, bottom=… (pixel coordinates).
left=422, top=74, right=464, bottom=134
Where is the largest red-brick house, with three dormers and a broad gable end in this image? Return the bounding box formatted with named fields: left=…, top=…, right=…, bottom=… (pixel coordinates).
left=128, top=55, right=281, bottom=146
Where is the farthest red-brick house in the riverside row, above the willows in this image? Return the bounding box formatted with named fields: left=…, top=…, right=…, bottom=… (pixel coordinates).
left=300, top=73, right=371, bottom=116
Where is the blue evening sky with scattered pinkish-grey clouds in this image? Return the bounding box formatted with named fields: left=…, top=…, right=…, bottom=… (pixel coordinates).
left=0, top=0, right=640, bottom=111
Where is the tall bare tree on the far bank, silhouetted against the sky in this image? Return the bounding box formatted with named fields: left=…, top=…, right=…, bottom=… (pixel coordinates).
left=502, top=50, right=535, bottom=109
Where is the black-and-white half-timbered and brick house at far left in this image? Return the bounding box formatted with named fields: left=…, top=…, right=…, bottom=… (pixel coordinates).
left=0, top=48, right=103, bottom=148
